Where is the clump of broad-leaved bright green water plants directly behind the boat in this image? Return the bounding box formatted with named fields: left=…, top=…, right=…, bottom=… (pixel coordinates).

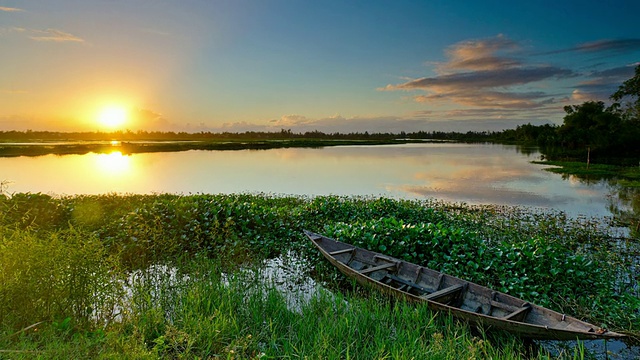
left=325, top=218, right=616, bottom=315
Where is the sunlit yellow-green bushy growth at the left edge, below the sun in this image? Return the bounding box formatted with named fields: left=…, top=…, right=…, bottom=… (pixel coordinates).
left=0, top=227, right=121, bottom=328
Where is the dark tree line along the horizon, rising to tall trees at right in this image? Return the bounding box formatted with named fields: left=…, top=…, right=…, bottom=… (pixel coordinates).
left=0, top=65, right=640, bottom=164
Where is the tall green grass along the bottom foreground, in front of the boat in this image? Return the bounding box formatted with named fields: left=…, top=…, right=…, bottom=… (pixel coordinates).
left=0, top=255, right=581, bottom=359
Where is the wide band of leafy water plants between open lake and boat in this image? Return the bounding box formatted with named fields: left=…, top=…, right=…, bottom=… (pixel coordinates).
left=0, top=194, right=640, bottom=338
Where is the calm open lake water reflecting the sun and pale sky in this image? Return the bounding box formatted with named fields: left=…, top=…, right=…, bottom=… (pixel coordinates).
left=0, top=143, right=611, bottom=216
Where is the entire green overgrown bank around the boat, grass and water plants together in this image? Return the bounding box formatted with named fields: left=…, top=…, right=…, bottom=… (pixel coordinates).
left=0, top=194, right=640, bottom=358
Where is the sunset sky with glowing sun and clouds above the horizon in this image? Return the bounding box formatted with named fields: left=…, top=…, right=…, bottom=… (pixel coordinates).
left=0, top=0, right=640, bottom=133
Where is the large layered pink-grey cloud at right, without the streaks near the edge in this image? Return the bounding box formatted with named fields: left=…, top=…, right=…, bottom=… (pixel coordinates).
left=380, top=35, right=576, bottom=114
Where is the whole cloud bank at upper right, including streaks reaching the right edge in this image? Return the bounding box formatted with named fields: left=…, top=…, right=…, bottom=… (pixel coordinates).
left=378, top=35, right=640, bottom=121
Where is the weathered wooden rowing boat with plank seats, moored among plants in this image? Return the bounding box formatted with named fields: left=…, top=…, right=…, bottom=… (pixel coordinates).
left=304, top=230, right=625, bottom=340
